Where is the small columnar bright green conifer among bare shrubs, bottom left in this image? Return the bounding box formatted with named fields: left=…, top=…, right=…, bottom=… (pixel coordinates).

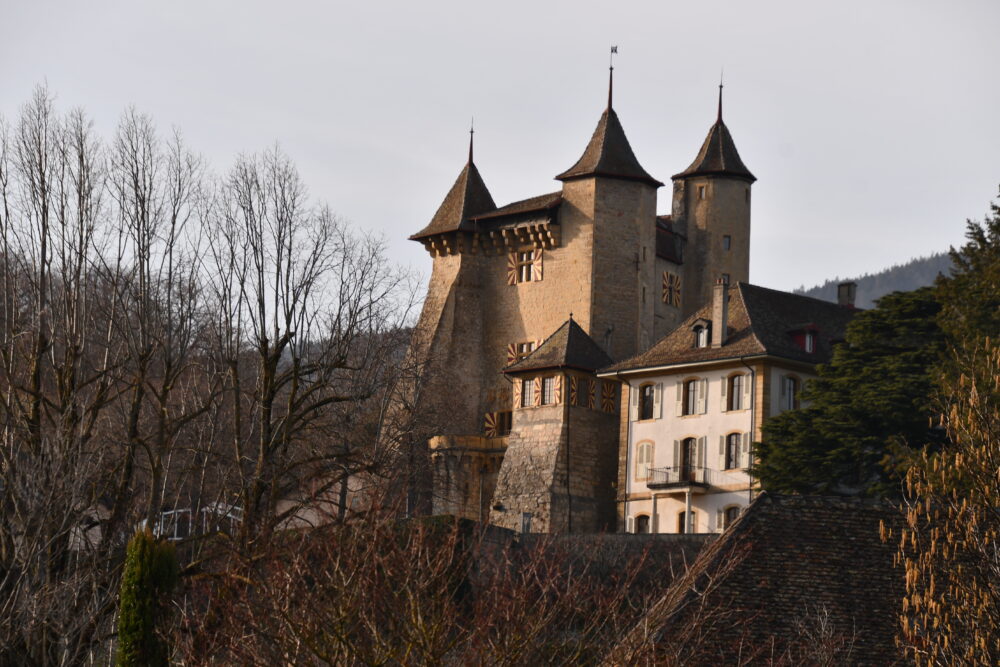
left=116, top=528, right=179, bottom=667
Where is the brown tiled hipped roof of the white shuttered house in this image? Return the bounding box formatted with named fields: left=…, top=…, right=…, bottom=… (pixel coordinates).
left=603, top=283, right=858, bottom=371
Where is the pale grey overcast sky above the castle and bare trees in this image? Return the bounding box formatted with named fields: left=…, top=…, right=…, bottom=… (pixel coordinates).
left=0, top=0, right=1000, bottom=289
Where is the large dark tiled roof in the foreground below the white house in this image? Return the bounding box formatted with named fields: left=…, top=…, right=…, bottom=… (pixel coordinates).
left=615, top=493, right=904, bottom=665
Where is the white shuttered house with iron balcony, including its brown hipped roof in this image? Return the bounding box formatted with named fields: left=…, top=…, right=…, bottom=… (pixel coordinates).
left=598, top=281, right=856, bottom=533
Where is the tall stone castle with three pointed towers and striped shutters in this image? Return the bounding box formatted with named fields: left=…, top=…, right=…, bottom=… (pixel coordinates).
left=410, top=77, right=754, bottom=532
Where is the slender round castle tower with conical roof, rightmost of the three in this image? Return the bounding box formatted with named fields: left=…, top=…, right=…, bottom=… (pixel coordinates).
left=672, top=84, right=757, bottom=316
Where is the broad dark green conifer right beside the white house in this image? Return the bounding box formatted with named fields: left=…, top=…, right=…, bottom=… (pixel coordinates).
left=756, top=287, right=945, bottom=495
